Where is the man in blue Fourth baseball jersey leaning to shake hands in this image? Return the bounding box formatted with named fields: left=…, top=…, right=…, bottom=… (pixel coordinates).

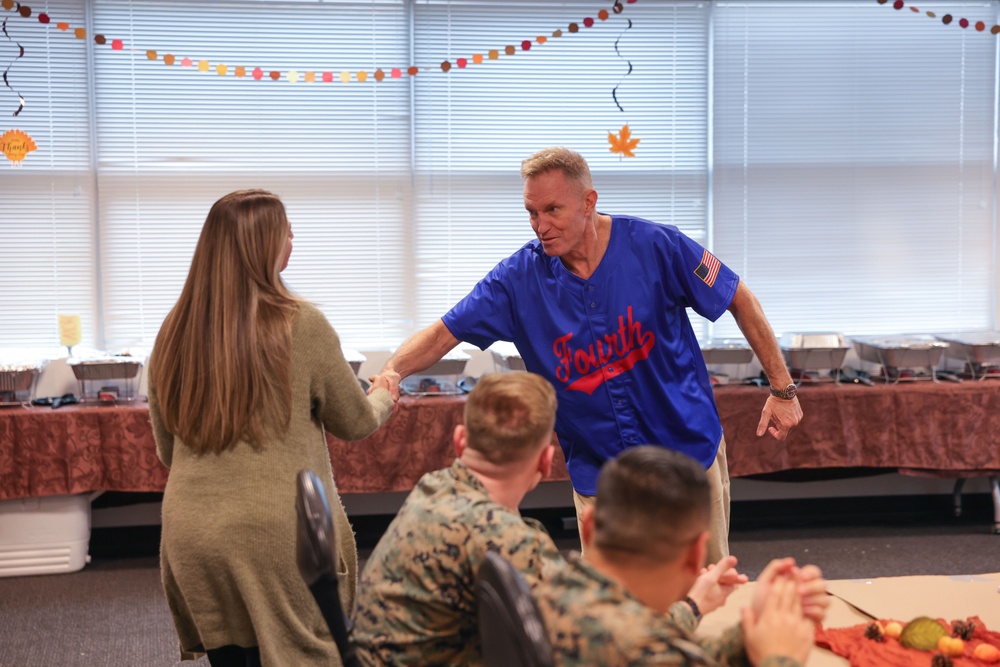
left=372, top=148, right=802, bottom=562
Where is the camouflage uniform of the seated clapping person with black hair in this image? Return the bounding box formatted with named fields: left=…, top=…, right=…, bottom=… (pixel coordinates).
left=534, top=556, right=798, bottom=667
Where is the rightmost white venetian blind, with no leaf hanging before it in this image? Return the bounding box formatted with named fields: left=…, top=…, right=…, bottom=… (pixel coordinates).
left=713, top=0, right=998, bottom=335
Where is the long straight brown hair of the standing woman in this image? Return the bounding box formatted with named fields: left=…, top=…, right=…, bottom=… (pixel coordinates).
left=149, top=190, right=299, bottom=453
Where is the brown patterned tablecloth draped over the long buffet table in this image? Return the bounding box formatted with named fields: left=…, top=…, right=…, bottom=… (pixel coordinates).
left=0, top=380, right=1000, bottom=500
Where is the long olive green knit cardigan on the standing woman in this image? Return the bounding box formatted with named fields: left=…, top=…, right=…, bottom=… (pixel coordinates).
left=149, top=304, right=393, bottom=665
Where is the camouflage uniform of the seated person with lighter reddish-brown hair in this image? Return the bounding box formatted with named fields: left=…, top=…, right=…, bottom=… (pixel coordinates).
left=352, top=460, right=565, bottom=665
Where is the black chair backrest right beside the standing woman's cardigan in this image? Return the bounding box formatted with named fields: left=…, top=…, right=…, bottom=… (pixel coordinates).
left=295, top=470, right=359, bottom=667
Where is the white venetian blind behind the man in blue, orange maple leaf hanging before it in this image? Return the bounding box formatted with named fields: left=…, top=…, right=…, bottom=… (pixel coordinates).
left=414, top=0, right=709, bottom=324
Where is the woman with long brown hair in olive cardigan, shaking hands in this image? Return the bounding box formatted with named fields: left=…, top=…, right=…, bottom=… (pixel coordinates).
left=149, top=190, right=393, bottom=667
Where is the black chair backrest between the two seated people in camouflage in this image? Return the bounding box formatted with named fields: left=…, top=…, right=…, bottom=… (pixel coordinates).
left=476, top=551, right=553, bottom=667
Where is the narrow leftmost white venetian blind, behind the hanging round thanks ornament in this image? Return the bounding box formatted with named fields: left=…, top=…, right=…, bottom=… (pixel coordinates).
left=0, top=0, right=98, bottom=352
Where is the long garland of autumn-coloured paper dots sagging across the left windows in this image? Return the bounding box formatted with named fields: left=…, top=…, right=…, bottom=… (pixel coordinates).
left=0, top=0, right=637, bottom=83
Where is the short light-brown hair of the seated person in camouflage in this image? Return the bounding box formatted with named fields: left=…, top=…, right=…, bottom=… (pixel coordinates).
left=465, top=371, right=556, bottom=465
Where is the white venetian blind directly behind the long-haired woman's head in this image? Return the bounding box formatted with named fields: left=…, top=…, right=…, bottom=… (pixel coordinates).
left=93, top=0, right=410, bottom=347
